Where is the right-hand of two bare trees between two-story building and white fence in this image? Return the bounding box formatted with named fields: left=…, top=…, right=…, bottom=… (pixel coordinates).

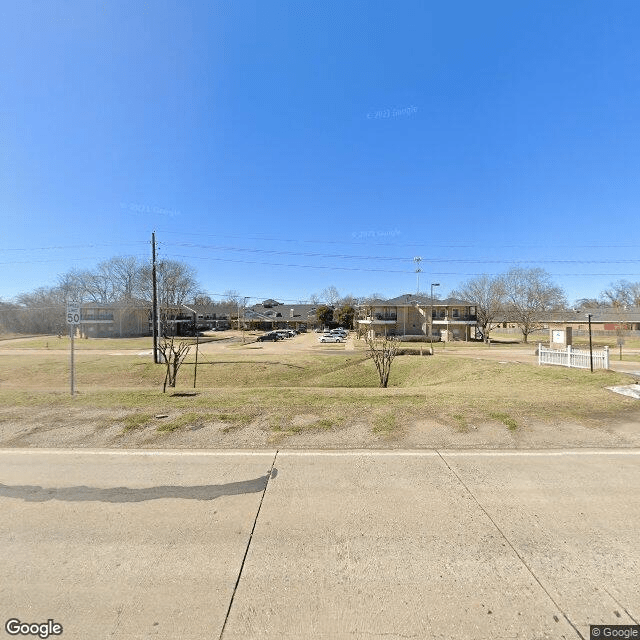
left=503, top=267, right=567, bottom=342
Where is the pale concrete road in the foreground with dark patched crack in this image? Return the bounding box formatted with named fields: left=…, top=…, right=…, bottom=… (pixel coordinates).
left=0, top=450, right=640, bottom=640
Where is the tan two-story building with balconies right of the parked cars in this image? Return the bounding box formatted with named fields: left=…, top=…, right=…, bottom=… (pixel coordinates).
left=358, top=293, right=477, bottom=342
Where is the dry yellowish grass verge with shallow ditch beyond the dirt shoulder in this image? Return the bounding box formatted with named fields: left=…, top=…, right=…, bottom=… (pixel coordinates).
left=0, top=347, right=637, bottom=437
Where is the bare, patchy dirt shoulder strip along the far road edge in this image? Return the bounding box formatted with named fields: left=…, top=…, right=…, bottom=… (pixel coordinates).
left=0, top=409, right=640, bottom=449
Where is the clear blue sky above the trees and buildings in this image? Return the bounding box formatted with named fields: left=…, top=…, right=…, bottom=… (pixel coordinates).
left=0, top=0, right=640, bottom=301
